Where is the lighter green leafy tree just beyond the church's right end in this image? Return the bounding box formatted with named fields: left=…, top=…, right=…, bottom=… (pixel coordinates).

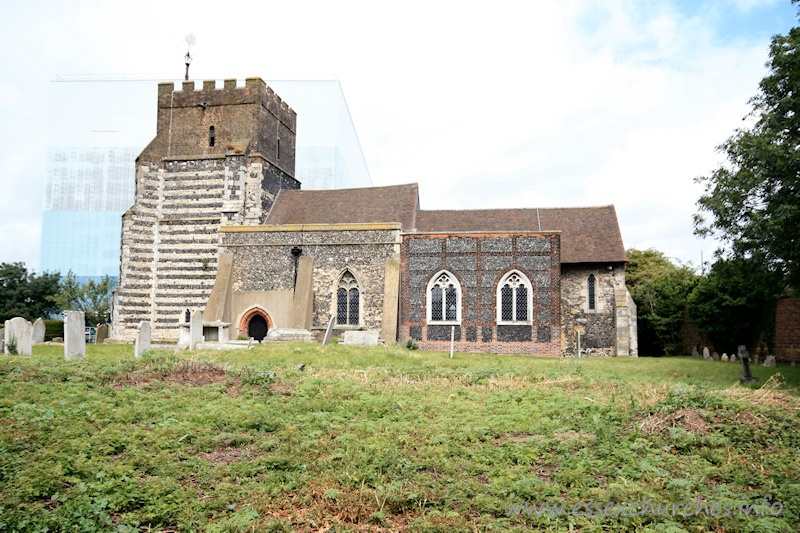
left=626, top=249, right=698, bottom=355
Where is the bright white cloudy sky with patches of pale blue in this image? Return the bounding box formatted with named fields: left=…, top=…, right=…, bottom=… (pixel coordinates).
left=0, top=0, right=798, bottom=270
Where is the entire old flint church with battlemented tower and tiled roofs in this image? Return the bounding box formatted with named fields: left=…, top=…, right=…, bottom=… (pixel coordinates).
left=112, top=78, right=637, bottom=356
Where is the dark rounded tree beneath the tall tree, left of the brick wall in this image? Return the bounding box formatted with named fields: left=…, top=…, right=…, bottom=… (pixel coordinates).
left=689, top=256, right=783, bottom=353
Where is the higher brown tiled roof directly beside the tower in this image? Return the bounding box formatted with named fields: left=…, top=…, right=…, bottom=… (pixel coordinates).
left=267, top=183, right=419, bottom=231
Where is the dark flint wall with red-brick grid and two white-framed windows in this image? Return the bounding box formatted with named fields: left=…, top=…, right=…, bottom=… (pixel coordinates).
left=398, top=233, right=560, bottom=355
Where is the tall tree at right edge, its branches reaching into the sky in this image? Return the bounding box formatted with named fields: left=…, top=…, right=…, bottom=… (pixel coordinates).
left=695, top=8, right=800, bottom=289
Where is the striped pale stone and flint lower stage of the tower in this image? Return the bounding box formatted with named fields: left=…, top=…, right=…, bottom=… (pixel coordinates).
left=113, top=155, right=292, bottom=340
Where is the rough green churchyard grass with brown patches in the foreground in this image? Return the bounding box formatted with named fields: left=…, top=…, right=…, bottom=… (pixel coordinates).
left=0, top=344, right=800, bottom=532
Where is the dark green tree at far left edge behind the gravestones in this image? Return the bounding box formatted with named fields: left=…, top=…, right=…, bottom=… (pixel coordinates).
left=0, top=263, right=60, bottom=323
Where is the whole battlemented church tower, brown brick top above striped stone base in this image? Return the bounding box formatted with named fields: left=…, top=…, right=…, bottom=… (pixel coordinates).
left=112, top=78, right=300, bottom=340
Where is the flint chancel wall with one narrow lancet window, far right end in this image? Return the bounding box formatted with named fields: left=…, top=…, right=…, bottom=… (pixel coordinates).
left=561, top=264, right=627, bottom=356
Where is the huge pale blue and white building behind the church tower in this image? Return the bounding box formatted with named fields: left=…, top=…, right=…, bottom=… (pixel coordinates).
left=40, top=80, right=372, bottom=282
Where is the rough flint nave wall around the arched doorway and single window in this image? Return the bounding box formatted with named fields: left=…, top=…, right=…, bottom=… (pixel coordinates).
left=221, top=225, right=399, bottom=336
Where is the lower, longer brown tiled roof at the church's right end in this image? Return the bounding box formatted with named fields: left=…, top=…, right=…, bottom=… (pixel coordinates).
left=416, top=205, right=628, bottom=263
